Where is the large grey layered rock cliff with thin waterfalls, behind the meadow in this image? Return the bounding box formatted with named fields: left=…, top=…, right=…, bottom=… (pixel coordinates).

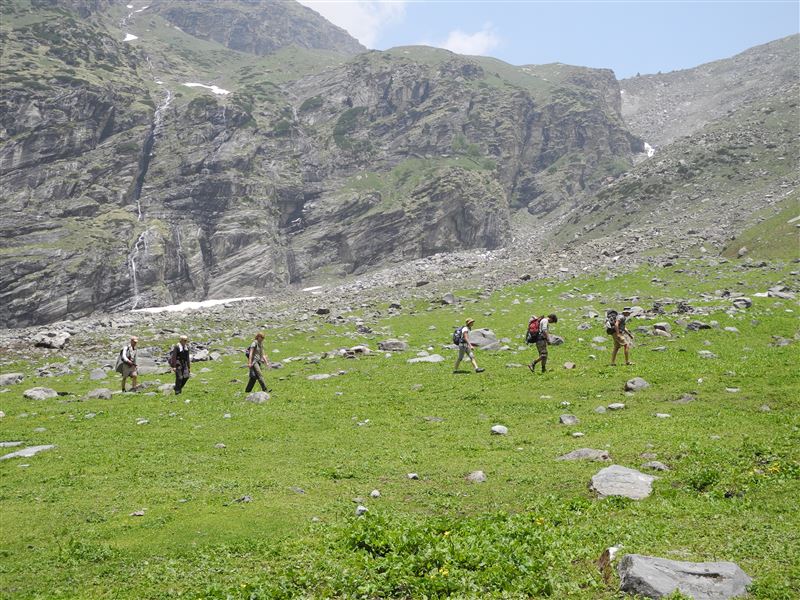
left=0, top=0, right=641, bottom=327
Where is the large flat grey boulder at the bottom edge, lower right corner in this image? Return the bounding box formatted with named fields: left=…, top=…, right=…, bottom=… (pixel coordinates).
left=618, top=554, right=753, bottom=600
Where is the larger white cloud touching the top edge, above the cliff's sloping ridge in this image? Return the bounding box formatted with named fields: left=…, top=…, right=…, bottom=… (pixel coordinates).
left=299, top=0, right=406, bottom=48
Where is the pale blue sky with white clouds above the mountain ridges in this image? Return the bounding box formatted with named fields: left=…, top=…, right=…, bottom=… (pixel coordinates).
left=299, top=0, right=800, bottom=79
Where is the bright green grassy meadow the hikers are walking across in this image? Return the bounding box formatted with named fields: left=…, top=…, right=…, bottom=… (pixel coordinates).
left=0, top=262, right=800, bottom=599
